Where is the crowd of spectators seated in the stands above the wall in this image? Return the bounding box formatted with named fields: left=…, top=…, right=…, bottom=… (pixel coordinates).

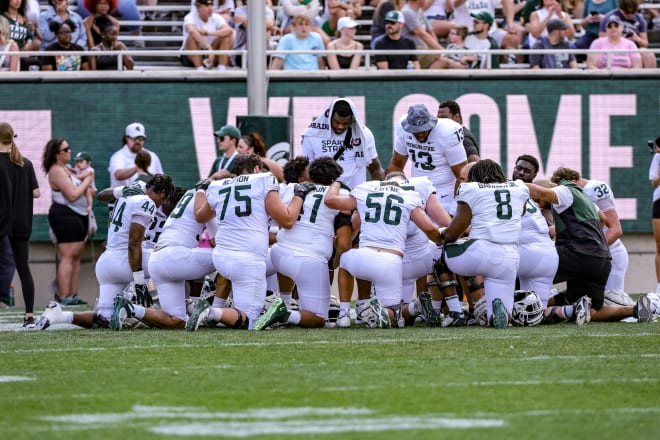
left=0, top=0, right=660, bottom=70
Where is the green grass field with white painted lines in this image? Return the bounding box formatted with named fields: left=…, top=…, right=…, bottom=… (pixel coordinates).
left=0, top=311, right=660, bottom=440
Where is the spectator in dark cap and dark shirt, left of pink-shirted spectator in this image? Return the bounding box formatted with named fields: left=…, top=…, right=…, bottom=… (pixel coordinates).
left=529, top=18, right=577, bottom=69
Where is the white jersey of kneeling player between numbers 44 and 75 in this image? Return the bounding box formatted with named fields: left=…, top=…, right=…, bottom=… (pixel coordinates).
left=158, top=189, right=204, bottom=249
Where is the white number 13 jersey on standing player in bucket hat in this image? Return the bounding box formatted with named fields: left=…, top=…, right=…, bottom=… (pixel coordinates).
left=394, top=116, right=467, bottom=190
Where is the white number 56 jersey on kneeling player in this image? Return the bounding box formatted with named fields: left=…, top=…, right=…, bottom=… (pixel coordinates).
left=351, top=181, right=424, bottom=252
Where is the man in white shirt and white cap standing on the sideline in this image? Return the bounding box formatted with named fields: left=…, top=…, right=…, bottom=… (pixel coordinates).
left=108, top=122, right=163, bottom=188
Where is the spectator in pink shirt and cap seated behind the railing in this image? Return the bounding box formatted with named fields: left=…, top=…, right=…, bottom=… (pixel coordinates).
left=587, top=14, right=642, bottom=69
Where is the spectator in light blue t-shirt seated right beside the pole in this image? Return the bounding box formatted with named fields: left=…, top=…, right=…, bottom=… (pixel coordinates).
left=270, top=15, right=325, bottom=70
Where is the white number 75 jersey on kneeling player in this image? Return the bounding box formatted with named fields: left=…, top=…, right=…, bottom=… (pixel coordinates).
left=206, top=173, right=279, bottom=257
